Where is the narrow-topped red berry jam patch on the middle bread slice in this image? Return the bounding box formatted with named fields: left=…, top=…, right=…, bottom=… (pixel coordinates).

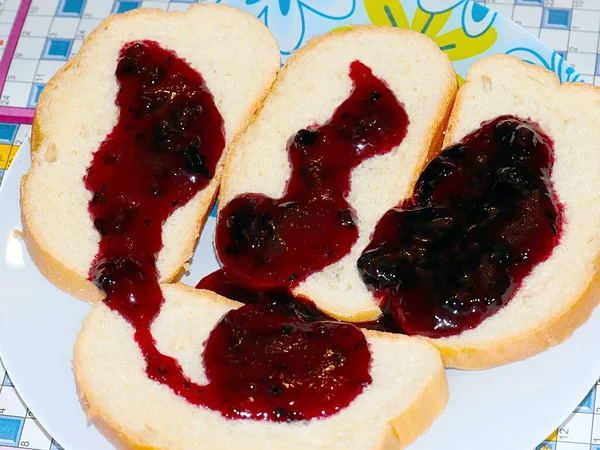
left=215, top=61, right=408, bottom=290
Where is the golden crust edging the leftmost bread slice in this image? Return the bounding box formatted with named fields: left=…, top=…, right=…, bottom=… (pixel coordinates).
left=20, top=4, right=277, bottom=304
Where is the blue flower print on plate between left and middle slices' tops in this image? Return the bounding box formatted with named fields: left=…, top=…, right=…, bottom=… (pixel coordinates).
left=217, top=0, right=356, bottom=55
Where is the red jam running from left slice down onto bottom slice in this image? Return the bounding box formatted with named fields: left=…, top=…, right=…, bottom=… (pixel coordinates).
left=84, top=41, right=371, bottom=422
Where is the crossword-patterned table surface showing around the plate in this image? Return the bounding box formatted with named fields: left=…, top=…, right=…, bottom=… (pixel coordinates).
left=0, top=0, right=600, bottom=450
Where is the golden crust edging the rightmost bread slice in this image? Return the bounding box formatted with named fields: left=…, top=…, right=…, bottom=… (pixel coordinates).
left=422, top=55, right=600, bottom=370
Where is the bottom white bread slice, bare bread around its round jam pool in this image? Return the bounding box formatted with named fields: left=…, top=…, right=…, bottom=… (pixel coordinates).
left=73, top=284, right=448, bottom=450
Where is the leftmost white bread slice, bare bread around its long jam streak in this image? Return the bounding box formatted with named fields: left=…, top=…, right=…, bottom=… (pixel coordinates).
left=21, top=5, right=280, bottom=302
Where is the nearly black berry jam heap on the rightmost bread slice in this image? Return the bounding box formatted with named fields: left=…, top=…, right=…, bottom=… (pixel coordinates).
left=358, top=116, right=563, bottom=337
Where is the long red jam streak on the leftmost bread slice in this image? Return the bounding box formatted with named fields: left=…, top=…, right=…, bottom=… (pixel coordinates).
left=84, top=41, right=225, bottom=328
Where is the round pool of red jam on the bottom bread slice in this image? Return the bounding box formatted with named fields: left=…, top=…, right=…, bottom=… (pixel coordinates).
left=203, top=302, right=371, bottom=422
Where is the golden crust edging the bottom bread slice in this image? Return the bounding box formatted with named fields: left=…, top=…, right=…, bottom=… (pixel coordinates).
left=73, top=283, right=449, bottom=450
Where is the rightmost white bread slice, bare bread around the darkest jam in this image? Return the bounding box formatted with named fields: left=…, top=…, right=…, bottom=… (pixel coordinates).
left=430, top=55, right=600, bottom=369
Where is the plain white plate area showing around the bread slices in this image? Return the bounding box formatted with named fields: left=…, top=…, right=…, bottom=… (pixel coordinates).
left=0, top=138, right=600, bottom=450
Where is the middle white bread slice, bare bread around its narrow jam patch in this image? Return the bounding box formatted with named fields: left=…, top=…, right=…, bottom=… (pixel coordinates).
left=219, top=25, right=457, bottom=322
